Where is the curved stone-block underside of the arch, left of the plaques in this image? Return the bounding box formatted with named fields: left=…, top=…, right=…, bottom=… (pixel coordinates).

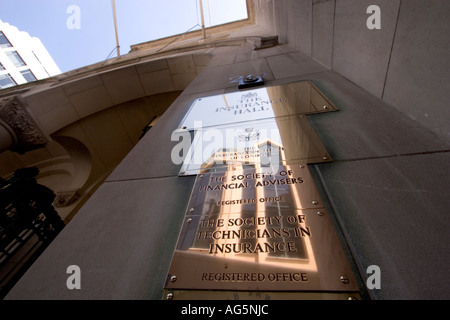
left=23, top=53, right=211, bottom=135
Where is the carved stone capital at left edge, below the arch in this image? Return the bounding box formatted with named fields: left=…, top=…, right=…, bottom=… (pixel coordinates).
left=0, top=96, right=48, bottom=154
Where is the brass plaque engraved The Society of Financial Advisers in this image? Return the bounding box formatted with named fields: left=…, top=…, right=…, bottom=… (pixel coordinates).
left=186, top=165, right=323, bottom=215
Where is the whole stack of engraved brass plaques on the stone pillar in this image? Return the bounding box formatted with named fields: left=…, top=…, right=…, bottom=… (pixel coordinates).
left=165, top=81, right=359, bottom=299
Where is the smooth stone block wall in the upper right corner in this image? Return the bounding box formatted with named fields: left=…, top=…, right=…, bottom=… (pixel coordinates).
left=268, top=0, right=450, bottom=141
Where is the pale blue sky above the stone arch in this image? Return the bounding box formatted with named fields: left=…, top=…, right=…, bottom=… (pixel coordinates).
left=0, top=0, right=246, bottom=72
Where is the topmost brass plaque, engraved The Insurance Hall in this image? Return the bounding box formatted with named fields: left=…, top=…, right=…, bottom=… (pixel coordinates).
left=180, top=81, right=337, bottom=130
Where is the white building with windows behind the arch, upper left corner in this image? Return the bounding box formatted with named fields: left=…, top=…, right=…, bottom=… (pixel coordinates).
left=0, top=20, right=61, bottom=89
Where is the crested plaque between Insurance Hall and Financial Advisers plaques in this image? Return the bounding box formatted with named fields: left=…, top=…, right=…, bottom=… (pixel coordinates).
left=180, top=115, right=331, bottom=176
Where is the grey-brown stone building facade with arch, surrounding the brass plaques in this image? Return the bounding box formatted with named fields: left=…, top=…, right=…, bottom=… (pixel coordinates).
left=0, top=0, right=450, bottom=299
